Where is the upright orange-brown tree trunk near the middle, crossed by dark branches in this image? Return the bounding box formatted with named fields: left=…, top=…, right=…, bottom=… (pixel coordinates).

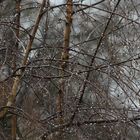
left=56, top=0, right=73, bottom=140
